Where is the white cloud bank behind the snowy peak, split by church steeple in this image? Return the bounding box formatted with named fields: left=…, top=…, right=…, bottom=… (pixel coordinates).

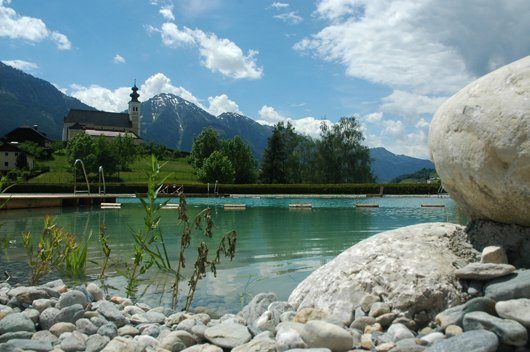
left=70, top=73, right=204, bottom=112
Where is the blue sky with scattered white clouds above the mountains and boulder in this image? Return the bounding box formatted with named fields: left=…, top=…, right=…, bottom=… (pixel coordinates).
left=0, top=0, right=530, bottom=158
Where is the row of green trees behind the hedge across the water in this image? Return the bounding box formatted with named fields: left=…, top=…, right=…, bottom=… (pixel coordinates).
left=189, top=117, right=374, bottom=184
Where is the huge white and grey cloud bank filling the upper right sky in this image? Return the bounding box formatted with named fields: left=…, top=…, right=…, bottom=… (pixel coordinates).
left=295, top=0, right=530, bottom=157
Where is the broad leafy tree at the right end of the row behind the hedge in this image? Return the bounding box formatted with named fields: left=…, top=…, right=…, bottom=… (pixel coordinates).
left=316, top=117, right=374, bottom=183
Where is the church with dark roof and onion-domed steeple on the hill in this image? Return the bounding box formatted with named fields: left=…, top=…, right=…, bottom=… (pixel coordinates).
left=62, top=83, right=141, bottom=141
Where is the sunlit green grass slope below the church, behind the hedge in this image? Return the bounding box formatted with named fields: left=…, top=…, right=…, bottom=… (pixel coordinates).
left=28, top=154, right=199, bottom=184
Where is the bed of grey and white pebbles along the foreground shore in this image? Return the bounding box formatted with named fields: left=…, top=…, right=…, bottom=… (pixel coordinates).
left=0, top=247, right=530, bottom=352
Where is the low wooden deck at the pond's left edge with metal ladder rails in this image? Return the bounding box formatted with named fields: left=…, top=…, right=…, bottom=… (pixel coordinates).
left=0, top=193, right=136, bottom=210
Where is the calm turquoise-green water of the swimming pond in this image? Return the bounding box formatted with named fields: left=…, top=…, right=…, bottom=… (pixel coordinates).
left=0, top=197, right=466, bottom=311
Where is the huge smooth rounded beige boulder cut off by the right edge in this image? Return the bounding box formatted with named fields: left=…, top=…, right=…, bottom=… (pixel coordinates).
left=429, top=56, right=530, bottom=226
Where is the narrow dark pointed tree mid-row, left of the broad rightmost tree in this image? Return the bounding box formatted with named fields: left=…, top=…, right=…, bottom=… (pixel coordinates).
left=260, top=123, right=287, bottom=183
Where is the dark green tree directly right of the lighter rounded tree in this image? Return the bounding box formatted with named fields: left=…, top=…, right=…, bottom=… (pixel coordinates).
left=222, top=136, right=257, bottom=184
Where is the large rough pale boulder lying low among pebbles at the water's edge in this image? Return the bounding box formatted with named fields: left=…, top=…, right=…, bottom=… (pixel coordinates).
left=289, top=223, right=480, bottom=324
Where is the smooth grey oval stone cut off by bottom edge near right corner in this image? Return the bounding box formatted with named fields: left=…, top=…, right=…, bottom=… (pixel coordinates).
left=425, top=330, right=499, bottom=352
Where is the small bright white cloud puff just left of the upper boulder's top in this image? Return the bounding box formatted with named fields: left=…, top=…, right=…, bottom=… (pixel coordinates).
left=380, top=90, right=447, bottom=119
